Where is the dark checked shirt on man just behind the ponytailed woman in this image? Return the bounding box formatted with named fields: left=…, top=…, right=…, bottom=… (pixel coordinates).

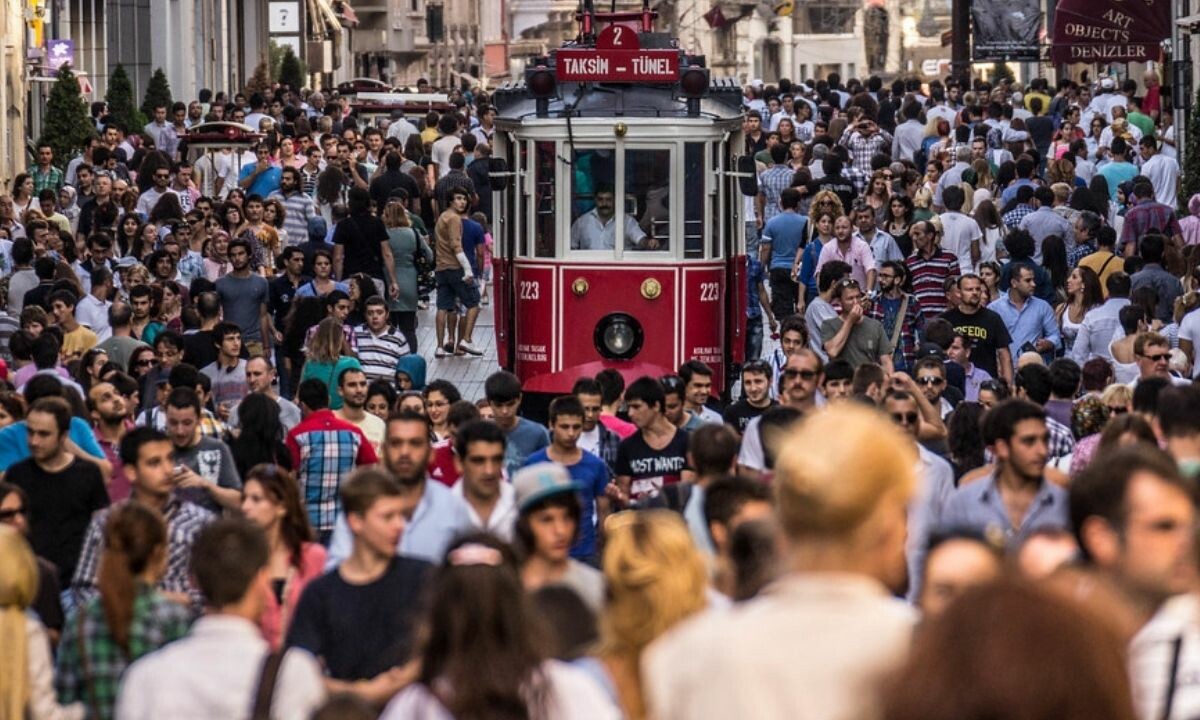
left=71, top=498, right=216, bottom=610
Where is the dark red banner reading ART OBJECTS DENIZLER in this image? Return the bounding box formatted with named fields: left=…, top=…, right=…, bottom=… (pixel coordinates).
left=1050, top=0, right=1171, bottom=62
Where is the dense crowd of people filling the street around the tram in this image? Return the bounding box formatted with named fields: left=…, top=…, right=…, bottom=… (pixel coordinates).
left=0, top=63, right=1200, bottom=720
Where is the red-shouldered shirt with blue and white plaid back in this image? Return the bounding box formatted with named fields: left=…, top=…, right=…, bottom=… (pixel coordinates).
left=287, top=409, right=378, bottom=533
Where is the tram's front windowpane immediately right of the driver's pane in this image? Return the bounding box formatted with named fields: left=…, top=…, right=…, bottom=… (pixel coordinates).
left=625, top=150, right=672, bottom=253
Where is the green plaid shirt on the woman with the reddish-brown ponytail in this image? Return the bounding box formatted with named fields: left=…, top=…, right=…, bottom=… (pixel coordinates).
left=54, top=584, right=191, bottom=720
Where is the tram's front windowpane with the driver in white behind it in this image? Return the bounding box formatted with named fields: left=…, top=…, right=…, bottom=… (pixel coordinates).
left=571, top=149, right=629, bottom=251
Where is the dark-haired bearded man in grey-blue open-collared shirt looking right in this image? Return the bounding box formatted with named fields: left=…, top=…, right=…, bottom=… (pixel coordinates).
left=942, top=398, right=1070, bottom=547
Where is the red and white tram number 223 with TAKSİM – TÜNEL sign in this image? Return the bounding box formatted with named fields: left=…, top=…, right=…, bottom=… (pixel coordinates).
left=492, top=4, right=754, bottom=394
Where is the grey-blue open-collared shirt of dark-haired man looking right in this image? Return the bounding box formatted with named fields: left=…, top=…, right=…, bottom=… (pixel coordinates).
left=941, top=475, right=1070, bottom=547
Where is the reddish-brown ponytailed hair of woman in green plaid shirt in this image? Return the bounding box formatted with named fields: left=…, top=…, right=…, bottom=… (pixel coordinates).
left=96, top=502, right=167, bottom=656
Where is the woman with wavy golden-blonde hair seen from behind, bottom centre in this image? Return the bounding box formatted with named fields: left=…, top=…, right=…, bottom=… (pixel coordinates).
left=596, top=510, right=708, bottom=720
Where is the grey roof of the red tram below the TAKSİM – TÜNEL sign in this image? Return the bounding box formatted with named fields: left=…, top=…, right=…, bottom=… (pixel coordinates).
left=492, top=78, right=742, bottom=122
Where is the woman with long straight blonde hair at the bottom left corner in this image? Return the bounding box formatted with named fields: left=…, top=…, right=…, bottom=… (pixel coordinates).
left=0, top=526, right=86, bottom=720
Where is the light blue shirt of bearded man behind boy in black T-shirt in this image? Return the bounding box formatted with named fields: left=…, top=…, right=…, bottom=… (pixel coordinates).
left=325, top=480, right=474, bottom=572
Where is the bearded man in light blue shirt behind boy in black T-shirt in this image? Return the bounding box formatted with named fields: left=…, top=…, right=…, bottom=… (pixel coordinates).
left=325, top=410, right=472, bottom=570
